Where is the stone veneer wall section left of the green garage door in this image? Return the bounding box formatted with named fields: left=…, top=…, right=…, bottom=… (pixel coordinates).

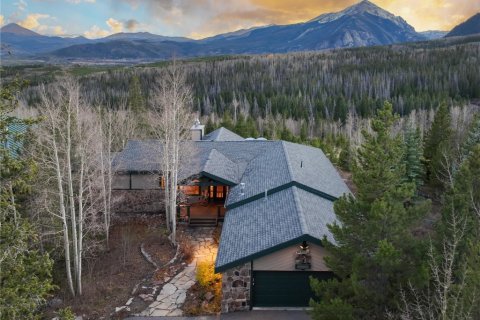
left=222, top=262, right=252, bottom=313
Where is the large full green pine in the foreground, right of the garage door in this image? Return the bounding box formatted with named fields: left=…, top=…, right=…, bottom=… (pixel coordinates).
left=312, top=103, right=429, bottom=319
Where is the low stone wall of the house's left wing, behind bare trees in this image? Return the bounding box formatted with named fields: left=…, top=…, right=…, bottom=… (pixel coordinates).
left=112, top=190, right=165, bottom=214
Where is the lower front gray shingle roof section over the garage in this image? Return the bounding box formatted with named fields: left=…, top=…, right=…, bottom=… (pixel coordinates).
left=215, top=187, right=336, bottom=270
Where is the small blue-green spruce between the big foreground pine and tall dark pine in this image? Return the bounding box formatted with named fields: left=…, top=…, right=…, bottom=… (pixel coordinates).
left=403, top=127, right=425, bottom=188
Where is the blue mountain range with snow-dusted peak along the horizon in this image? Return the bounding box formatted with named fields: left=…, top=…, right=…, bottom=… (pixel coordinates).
left=0, top=0, right=480, bottom=60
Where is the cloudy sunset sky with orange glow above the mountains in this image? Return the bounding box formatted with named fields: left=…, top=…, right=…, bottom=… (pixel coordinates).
left=0, top=0, right=480, bottom=39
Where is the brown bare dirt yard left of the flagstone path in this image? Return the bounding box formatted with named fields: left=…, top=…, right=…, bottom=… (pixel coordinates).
left=45, top=216, right=175, bottom=319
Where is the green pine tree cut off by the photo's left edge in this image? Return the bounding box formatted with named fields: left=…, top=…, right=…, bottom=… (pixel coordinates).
left=0, top=82, right=53, bottom=319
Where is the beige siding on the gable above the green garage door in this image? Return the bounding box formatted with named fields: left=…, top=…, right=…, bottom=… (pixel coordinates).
left=253, top=243, right=330, bottom=271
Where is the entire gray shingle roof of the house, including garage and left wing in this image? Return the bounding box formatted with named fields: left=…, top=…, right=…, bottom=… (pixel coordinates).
left=114, top=130, right=350, bottom=268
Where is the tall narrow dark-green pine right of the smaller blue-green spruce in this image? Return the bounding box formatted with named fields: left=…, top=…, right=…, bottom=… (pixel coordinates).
left=424, top=103, right=452, bottom=186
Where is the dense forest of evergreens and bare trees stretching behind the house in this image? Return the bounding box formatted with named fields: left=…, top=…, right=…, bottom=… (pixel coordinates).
left=2, top=37, right=480, bottom=166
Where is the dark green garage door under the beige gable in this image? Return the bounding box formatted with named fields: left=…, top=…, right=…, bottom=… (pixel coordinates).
left=252, top=271, right=333, bottom=307
